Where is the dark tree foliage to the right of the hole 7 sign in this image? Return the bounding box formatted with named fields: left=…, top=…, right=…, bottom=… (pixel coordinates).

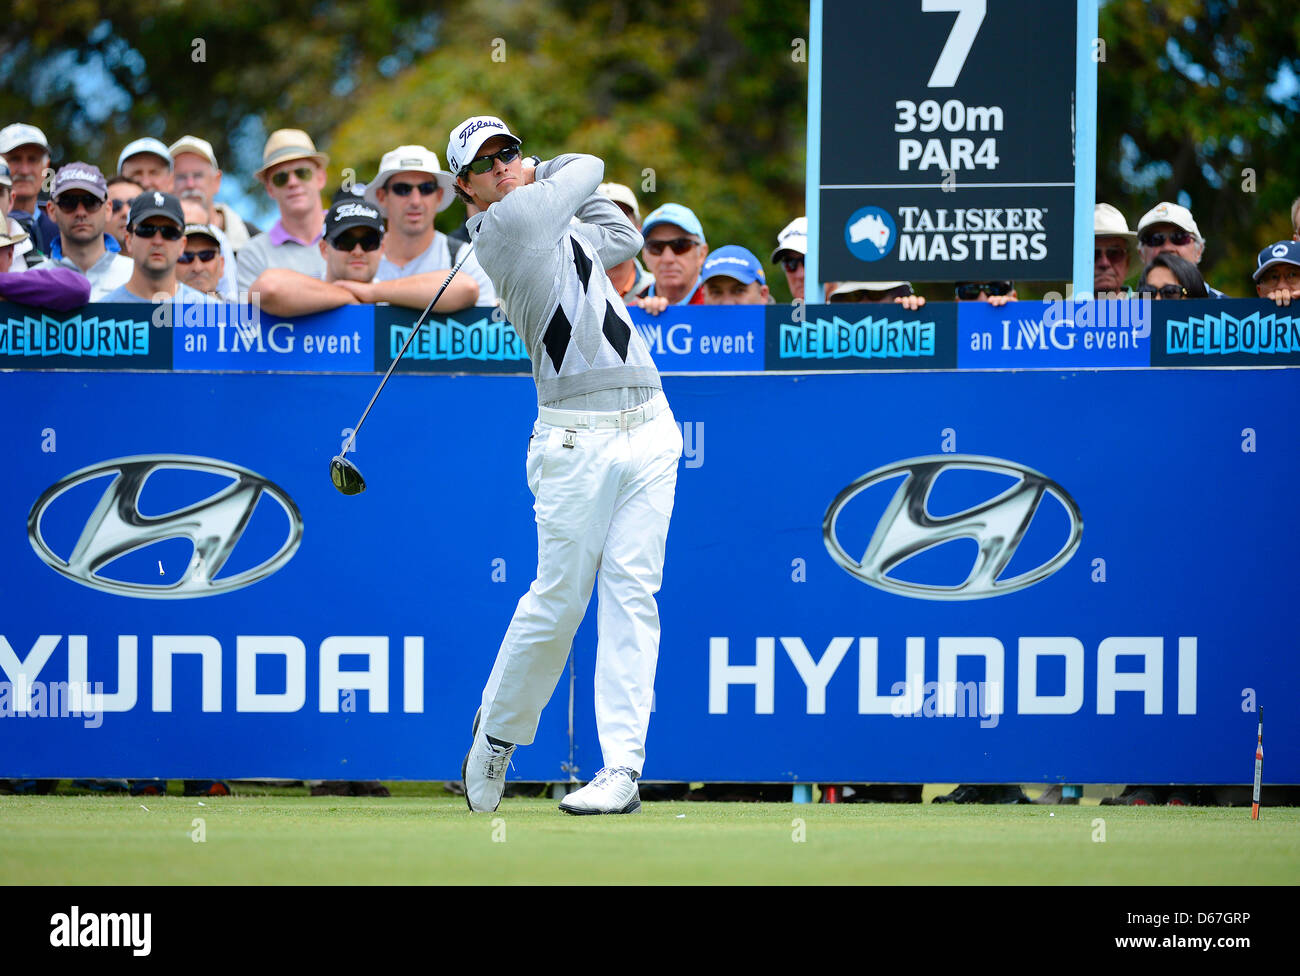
left=1097, top=0, right=1300, bottom=288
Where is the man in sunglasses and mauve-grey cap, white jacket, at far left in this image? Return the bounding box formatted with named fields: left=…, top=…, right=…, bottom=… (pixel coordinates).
left=34, top=162, right=135, bottom=302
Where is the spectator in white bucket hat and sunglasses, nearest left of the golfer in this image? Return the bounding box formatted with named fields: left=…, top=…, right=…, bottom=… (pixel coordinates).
left=365, top=146, right=483, bottom=312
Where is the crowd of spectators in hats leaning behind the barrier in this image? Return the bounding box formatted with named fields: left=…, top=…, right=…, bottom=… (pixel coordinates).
left=0, top=122, right=1300, bottom=316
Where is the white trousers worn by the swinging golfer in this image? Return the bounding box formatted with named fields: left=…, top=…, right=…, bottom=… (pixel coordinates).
left=481, top=400, right=681, bottom=775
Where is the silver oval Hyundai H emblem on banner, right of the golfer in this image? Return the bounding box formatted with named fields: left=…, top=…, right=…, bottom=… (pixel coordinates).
left=822, top=455, right=1083, bottom=600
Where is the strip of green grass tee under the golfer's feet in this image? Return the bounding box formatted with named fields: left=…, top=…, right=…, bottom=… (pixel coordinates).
left=0, top=790, right=1300, bottom=885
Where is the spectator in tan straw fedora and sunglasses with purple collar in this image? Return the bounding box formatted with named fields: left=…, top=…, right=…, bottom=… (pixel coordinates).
left=235, top=129, right=329, bottom=295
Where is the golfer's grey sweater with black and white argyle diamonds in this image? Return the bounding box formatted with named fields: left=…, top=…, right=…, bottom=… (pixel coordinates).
left=468, top=153, right=662, bottom=404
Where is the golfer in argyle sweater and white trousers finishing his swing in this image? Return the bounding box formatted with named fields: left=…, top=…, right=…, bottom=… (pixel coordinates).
left=447, top=116, right=681, bottom=814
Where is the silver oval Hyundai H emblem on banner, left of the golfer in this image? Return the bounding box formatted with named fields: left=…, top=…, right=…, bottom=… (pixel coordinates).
left=27, top=454, right=303, bottom=599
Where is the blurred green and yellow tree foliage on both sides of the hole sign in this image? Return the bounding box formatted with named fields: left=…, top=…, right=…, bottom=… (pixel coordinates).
left=0, top=0, right=1300, bottom=299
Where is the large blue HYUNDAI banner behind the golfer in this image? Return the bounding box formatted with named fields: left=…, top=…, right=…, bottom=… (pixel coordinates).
left=0, top=369, right=1300, bottom=782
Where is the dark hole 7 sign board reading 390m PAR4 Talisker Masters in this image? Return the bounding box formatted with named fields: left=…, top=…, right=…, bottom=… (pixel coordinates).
left=810, top=0, right=1078, bottom=281
